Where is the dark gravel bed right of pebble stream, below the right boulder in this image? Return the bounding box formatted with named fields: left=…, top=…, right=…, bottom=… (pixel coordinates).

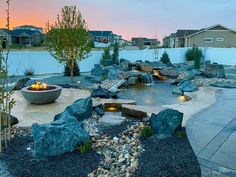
left=133, top=136, right=201, bottom=177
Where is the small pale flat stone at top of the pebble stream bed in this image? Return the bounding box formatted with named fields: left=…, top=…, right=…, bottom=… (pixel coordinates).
left=99, top=114, right=125, bottom=125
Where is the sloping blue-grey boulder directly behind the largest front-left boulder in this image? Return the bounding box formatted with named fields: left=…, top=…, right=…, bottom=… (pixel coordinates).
left=54, top=97, right=93, bottom=121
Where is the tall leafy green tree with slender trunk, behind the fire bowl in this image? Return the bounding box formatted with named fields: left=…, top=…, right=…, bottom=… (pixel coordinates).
left=46, top=6, right=91, bottom=81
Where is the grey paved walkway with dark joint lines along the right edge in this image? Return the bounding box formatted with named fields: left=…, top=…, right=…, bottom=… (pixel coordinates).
left=187, top=89, right=236, bottom=177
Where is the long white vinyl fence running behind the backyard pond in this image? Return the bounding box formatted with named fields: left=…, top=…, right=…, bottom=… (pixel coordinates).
left=8, top=48, right=236, bottom=75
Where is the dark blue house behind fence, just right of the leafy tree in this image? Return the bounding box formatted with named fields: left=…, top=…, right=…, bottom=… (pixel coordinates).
left=89, top=31, right=114, bottom=44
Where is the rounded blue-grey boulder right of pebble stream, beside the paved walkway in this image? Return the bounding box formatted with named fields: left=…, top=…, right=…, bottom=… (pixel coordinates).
left=150, top=109, right=183, bottom=137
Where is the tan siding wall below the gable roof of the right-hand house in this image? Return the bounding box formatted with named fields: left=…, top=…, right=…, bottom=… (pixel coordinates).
left=188, top=29, right=236, bottom=48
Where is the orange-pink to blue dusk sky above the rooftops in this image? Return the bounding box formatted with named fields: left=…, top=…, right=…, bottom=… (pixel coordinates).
left=0, top=0, right=236, bottom=39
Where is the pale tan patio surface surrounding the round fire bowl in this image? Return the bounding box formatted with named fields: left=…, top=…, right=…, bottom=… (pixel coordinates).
left=12, top=89, right=91, bottom=127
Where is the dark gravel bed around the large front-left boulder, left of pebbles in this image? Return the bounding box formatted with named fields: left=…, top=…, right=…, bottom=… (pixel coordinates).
left=0, top=135, right=103, bottom=177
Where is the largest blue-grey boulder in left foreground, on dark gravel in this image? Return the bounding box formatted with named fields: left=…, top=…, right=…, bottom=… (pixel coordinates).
left=32, top=116, right=90, bottom=158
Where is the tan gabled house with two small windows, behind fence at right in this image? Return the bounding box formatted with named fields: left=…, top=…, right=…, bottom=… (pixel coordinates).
left=185, top=24, right=236, bottom=48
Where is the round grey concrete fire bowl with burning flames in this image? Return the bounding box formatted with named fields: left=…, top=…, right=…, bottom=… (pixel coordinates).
left=21, top=83, right=62, bottom=104
